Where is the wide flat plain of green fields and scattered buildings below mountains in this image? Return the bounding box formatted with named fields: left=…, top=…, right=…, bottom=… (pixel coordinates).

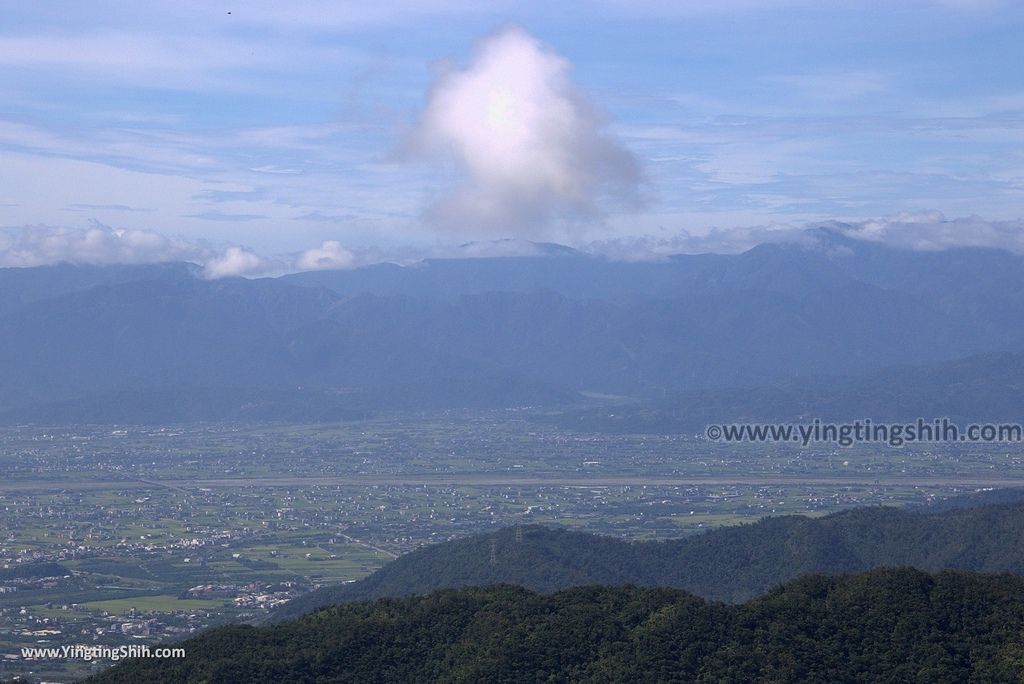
left=0, top=413, right=1024, bottom=679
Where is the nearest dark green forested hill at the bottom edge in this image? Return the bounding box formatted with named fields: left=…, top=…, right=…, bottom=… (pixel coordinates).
left=90, top=568, right=1024, bottom=684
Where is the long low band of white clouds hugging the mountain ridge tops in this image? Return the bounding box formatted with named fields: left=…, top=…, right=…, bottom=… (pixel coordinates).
left=6, top=212, right=1024, bottom=279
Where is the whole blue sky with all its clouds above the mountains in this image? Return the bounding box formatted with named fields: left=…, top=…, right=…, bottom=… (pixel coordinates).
left=0, top=0, right=1024, bottom=276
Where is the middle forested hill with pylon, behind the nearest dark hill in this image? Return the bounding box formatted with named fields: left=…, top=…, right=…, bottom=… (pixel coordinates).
left=269, top=503, right=1024, bottom=621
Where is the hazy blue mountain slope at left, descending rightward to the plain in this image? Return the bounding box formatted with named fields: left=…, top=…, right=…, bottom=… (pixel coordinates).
left=0, top=275, right=566, bottom=422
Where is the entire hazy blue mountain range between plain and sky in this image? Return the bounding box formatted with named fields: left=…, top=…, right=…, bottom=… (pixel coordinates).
left=0, top=229, right=1024, bottom=423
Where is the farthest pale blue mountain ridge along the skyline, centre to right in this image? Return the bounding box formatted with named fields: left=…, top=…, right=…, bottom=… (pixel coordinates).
left=283, top=228, right=1024, bottom=310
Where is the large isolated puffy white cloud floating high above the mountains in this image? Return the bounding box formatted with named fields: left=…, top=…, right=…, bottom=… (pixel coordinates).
left=413, top=27, right=642, bottom=238
